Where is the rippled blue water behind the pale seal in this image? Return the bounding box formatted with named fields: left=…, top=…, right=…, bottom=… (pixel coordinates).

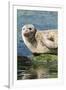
left=17, top=9, right=58, bottom=56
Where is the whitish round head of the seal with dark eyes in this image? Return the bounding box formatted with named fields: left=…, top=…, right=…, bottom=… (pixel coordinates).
left=22, top=24, right=36, bottom=38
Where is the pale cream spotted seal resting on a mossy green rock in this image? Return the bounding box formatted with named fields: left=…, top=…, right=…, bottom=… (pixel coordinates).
left=22, top=24, right=58, bottom=54
